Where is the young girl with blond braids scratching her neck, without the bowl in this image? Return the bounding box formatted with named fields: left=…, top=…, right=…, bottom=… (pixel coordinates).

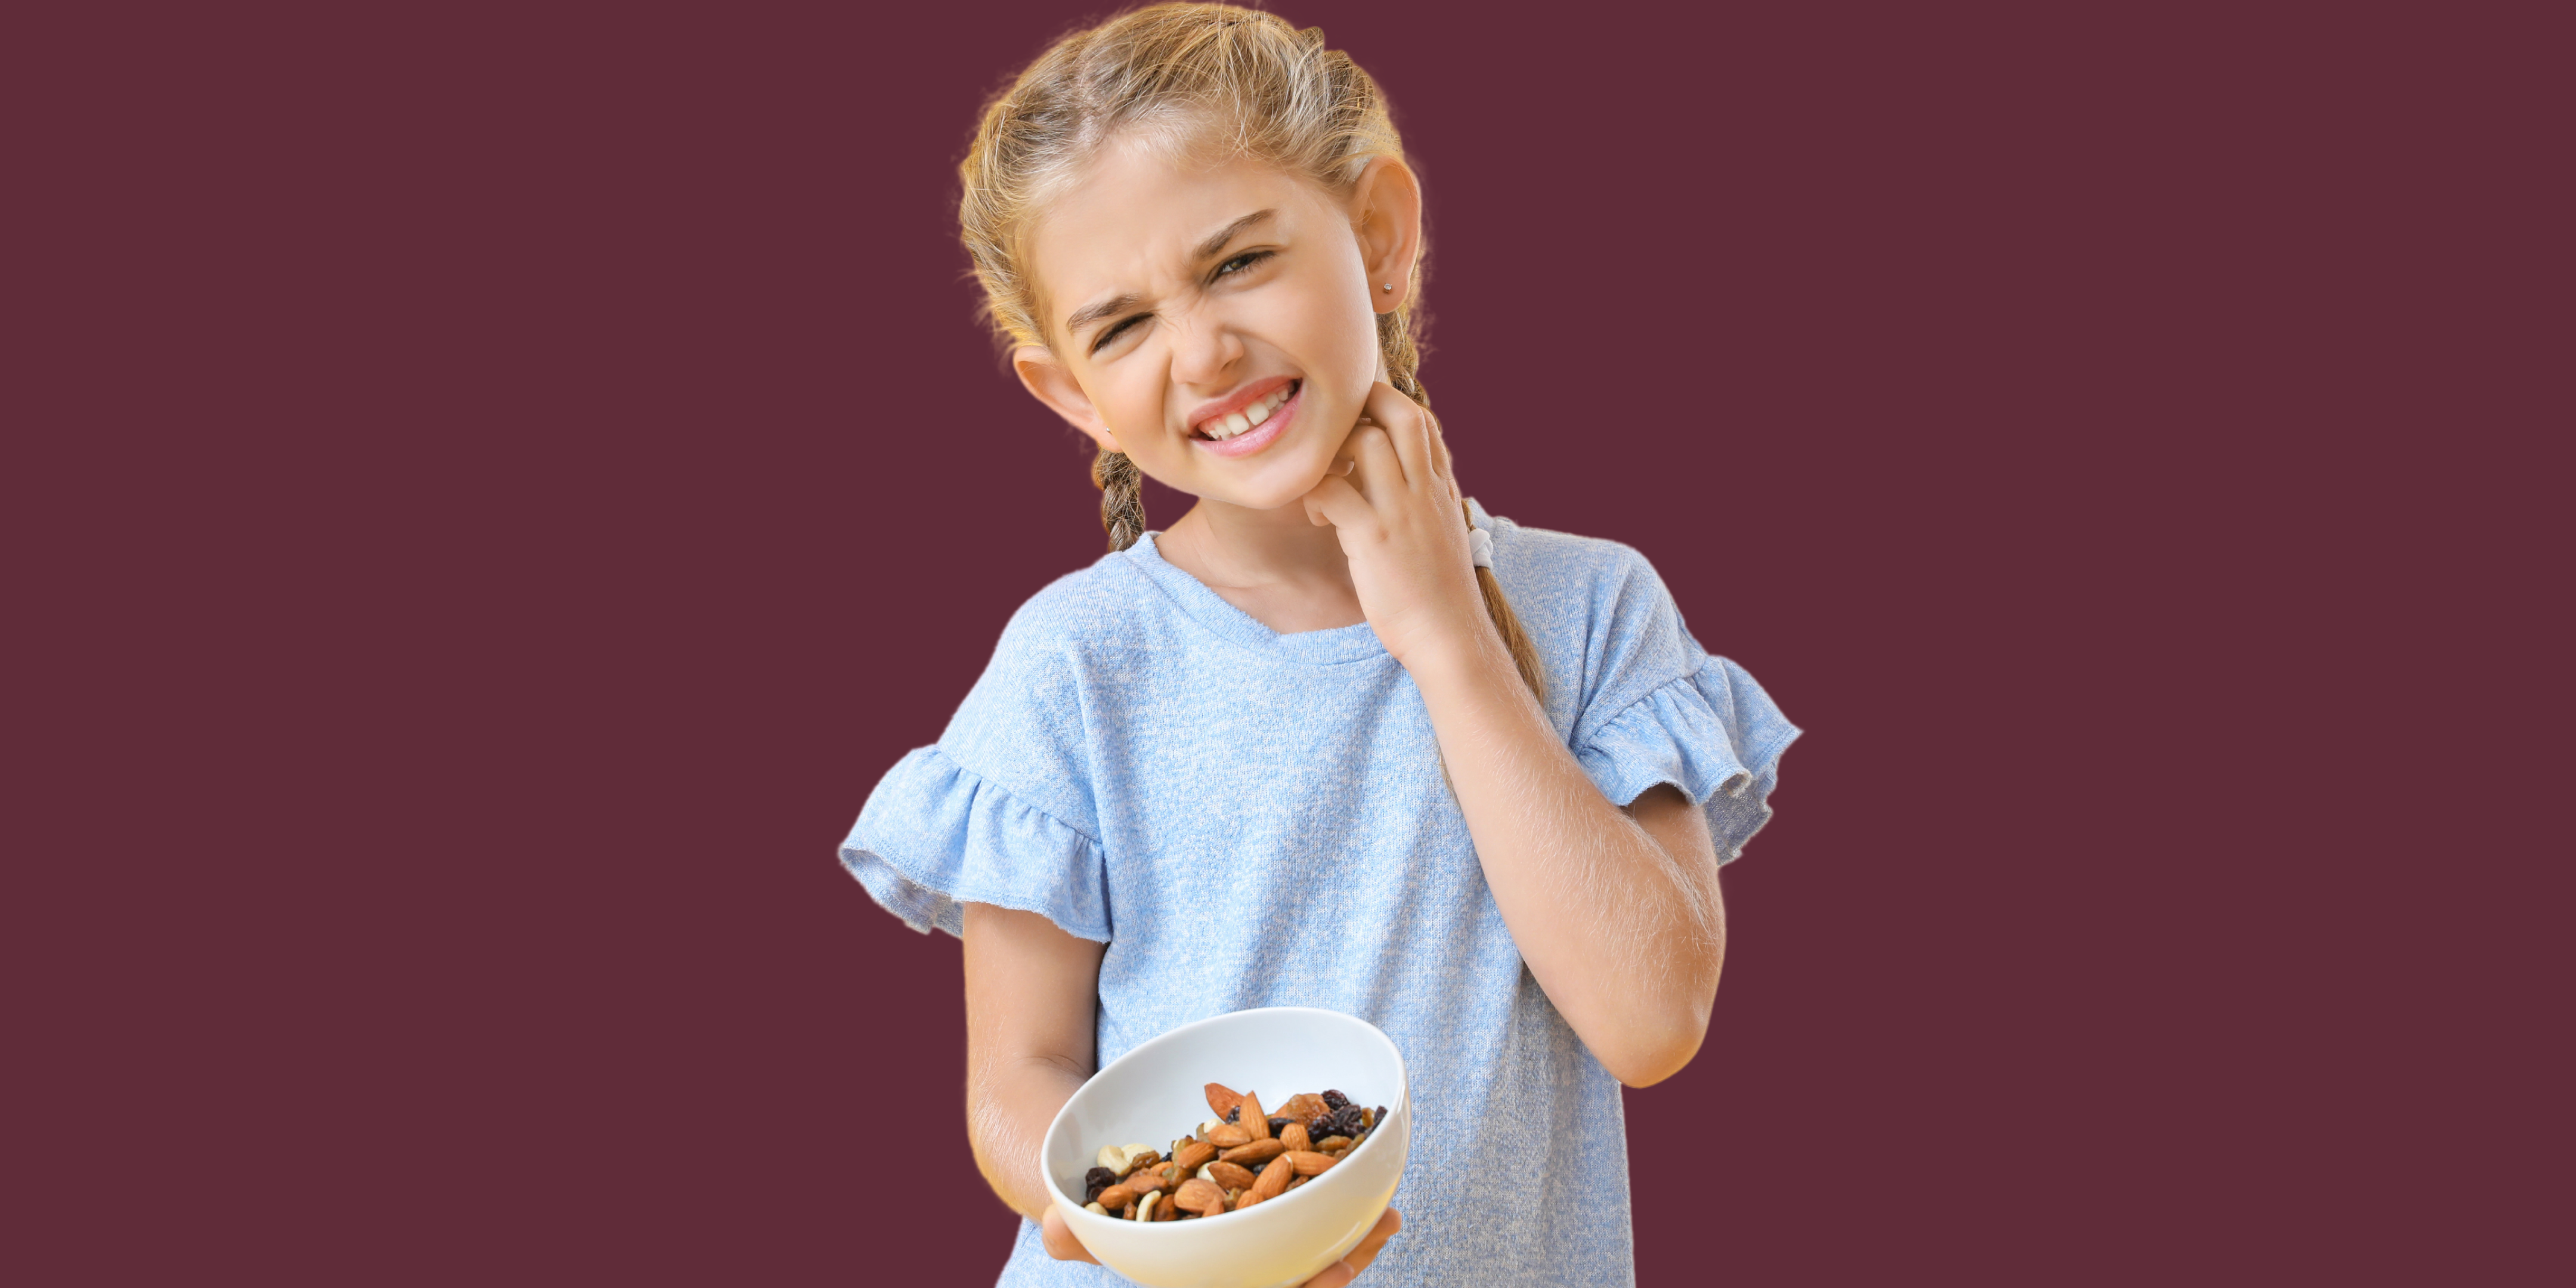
left=843, top=5, right=1798, bottom=1288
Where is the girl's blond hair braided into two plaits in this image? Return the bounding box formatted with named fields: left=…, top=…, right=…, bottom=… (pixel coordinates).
left=958, top=5, right=1546, bottom=695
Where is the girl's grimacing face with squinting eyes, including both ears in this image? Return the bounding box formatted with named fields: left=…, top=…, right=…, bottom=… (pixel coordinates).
left=1013, top=135, right=1422, bottom=510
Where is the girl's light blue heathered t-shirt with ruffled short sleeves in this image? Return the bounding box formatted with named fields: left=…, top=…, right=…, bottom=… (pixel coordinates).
left=840, top=507, right=1798, bottom=1288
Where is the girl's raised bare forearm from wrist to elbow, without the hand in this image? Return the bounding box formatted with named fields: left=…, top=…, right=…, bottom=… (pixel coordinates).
left=1409, top=631, right=1726, bottom=1085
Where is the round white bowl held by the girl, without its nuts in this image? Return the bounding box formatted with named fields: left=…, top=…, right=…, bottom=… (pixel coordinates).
left=1041, top=1007, right=1414, bottom=1288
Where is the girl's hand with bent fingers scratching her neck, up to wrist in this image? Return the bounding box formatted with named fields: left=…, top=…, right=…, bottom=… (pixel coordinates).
left=1304, top=381, right=1489, bottom=670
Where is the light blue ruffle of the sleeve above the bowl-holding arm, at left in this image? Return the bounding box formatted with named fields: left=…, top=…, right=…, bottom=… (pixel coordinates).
left=840, top=747, right=1110, bottom=943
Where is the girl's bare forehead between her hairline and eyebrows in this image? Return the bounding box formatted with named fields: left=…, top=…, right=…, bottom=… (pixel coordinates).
left=1028, top=144, right=1327, bottom=327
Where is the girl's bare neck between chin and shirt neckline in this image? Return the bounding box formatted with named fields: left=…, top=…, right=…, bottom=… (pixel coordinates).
left=1154, top=500, right=1368, bottom=634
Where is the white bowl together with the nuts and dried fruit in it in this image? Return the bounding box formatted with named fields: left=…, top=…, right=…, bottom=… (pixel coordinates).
left=1041, top=1007, right=1411, bottom=1288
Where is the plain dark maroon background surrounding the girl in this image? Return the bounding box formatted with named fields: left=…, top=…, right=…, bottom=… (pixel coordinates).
left=5, top=0, right=2568, bottom=1286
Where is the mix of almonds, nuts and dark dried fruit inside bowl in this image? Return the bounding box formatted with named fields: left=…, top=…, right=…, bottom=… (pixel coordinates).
left=1082, top=1082, right=1386, bottom=1221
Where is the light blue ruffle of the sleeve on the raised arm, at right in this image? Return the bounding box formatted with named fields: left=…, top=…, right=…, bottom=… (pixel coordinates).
left=1574, top=659, right=1798, bottom=863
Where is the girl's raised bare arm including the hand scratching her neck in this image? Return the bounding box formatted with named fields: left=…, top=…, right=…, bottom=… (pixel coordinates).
left=1306, top=384, right=1726, bottom=1087
